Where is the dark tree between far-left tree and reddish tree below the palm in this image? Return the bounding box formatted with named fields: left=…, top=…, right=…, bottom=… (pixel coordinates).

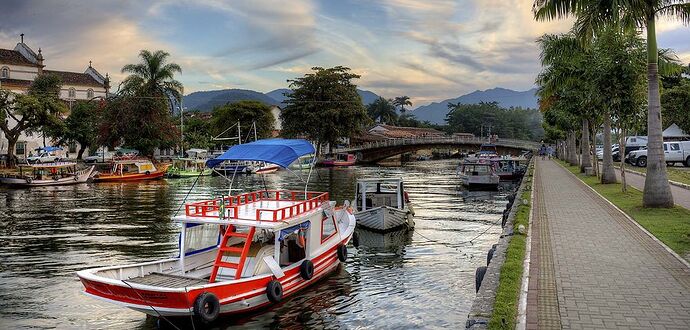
left=59, top=102, right=100, bottom=159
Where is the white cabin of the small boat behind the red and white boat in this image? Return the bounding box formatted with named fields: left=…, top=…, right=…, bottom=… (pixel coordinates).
left=355, top=178, right=406, bottom=212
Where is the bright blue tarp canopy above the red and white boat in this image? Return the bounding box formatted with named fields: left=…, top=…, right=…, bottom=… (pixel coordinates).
left=206, top=139, right=316, bottom=168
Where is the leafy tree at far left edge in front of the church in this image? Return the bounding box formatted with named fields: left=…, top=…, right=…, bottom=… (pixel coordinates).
left=0, top=74, right=67, bottom=166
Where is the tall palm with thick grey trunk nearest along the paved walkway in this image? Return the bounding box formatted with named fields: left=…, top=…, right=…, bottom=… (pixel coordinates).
left=533, top=0, right=690, bottom=207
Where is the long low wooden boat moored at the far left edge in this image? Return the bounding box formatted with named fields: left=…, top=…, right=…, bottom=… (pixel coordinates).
left=0, top=162, right=94, bottom=187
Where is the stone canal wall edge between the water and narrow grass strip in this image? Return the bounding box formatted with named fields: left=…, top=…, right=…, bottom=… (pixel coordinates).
left=465, top=157, right=534, bottom=329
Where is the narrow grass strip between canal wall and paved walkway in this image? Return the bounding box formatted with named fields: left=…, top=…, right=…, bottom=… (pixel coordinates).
left=489, top=167, right=533, bottom=329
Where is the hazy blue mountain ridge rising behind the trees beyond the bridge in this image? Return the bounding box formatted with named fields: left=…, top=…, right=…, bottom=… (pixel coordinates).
left=410, top=87, right=537, bottom=124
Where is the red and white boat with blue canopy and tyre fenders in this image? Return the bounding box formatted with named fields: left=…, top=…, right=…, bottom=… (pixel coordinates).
left=77, top=139, right=355, bottom=323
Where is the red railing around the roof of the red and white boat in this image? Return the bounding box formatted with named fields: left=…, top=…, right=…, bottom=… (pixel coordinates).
left=185, top=190, right=329, bottom=221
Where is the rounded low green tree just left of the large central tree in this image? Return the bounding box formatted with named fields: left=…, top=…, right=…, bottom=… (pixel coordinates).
left=211, top=101, right=274, bottom=140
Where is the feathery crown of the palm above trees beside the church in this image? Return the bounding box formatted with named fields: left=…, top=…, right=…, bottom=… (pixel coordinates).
left=122, top=50, right=184, bottom=101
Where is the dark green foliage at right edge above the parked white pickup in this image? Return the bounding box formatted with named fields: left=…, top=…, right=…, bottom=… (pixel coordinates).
left=661, top=78, right=690, bottom=132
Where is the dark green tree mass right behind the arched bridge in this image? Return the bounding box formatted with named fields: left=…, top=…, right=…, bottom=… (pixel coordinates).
left=446, top=102, right=544, bottom=141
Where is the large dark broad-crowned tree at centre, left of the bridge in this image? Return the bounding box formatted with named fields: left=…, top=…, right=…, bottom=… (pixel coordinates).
left=280, top=66, right=371, bottom=152
